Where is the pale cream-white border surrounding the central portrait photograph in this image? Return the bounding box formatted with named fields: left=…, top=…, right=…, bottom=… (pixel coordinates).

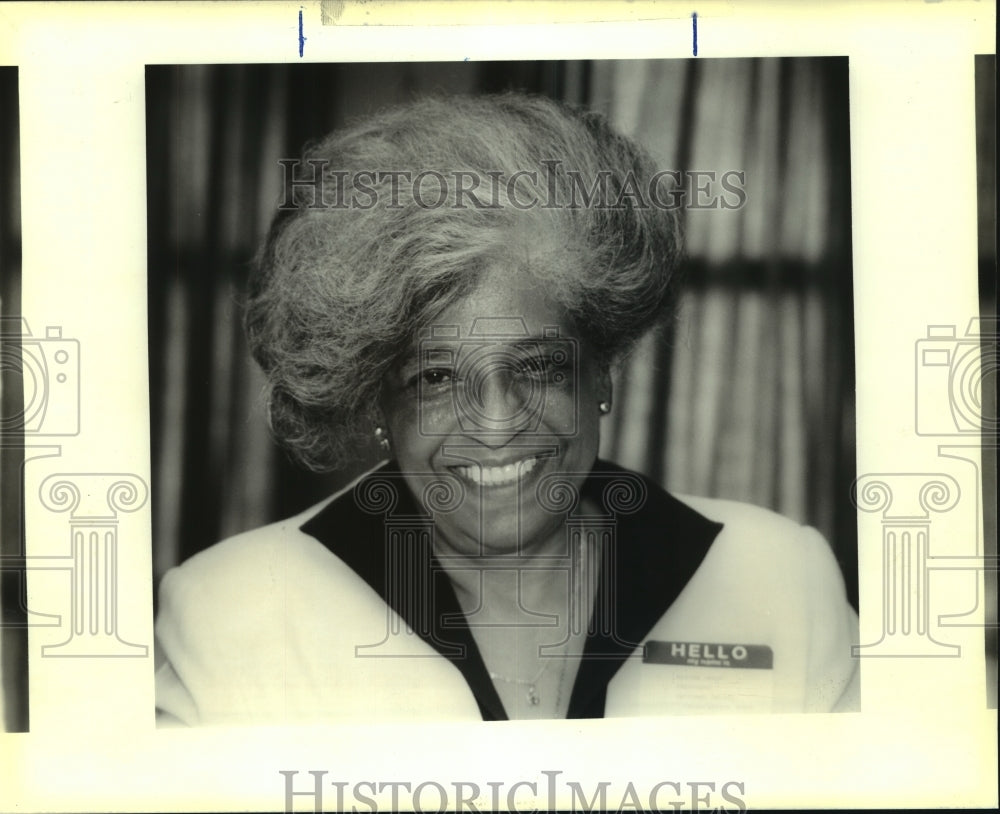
left=0, top=1, right=997, bottom=811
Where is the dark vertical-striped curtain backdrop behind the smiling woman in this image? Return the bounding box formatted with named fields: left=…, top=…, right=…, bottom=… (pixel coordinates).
left=146, top=58, right=857, bottom=603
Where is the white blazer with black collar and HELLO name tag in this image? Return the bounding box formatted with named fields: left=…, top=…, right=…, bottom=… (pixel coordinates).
left=156, top=462, right=858, bottom=725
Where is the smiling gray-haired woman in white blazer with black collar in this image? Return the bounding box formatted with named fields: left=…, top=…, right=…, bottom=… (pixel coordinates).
left=157, top=95, right=857, bottom=724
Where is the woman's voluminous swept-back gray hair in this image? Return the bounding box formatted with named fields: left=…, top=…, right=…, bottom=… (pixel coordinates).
left=245, top=94, right=680, bottom=470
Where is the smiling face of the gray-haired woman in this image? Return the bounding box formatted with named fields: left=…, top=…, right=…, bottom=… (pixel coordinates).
left=381, top=268, right=611, bottom=555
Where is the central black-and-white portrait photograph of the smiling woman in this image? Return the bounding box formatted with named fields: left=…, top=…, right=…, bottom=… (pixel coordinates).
left=146, top=58, right=859, bottom=725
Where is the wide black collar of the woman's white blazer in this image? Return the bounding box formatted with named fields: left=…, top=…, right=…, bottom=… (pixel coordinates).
left=302, top=461, right=722, bottom=721
